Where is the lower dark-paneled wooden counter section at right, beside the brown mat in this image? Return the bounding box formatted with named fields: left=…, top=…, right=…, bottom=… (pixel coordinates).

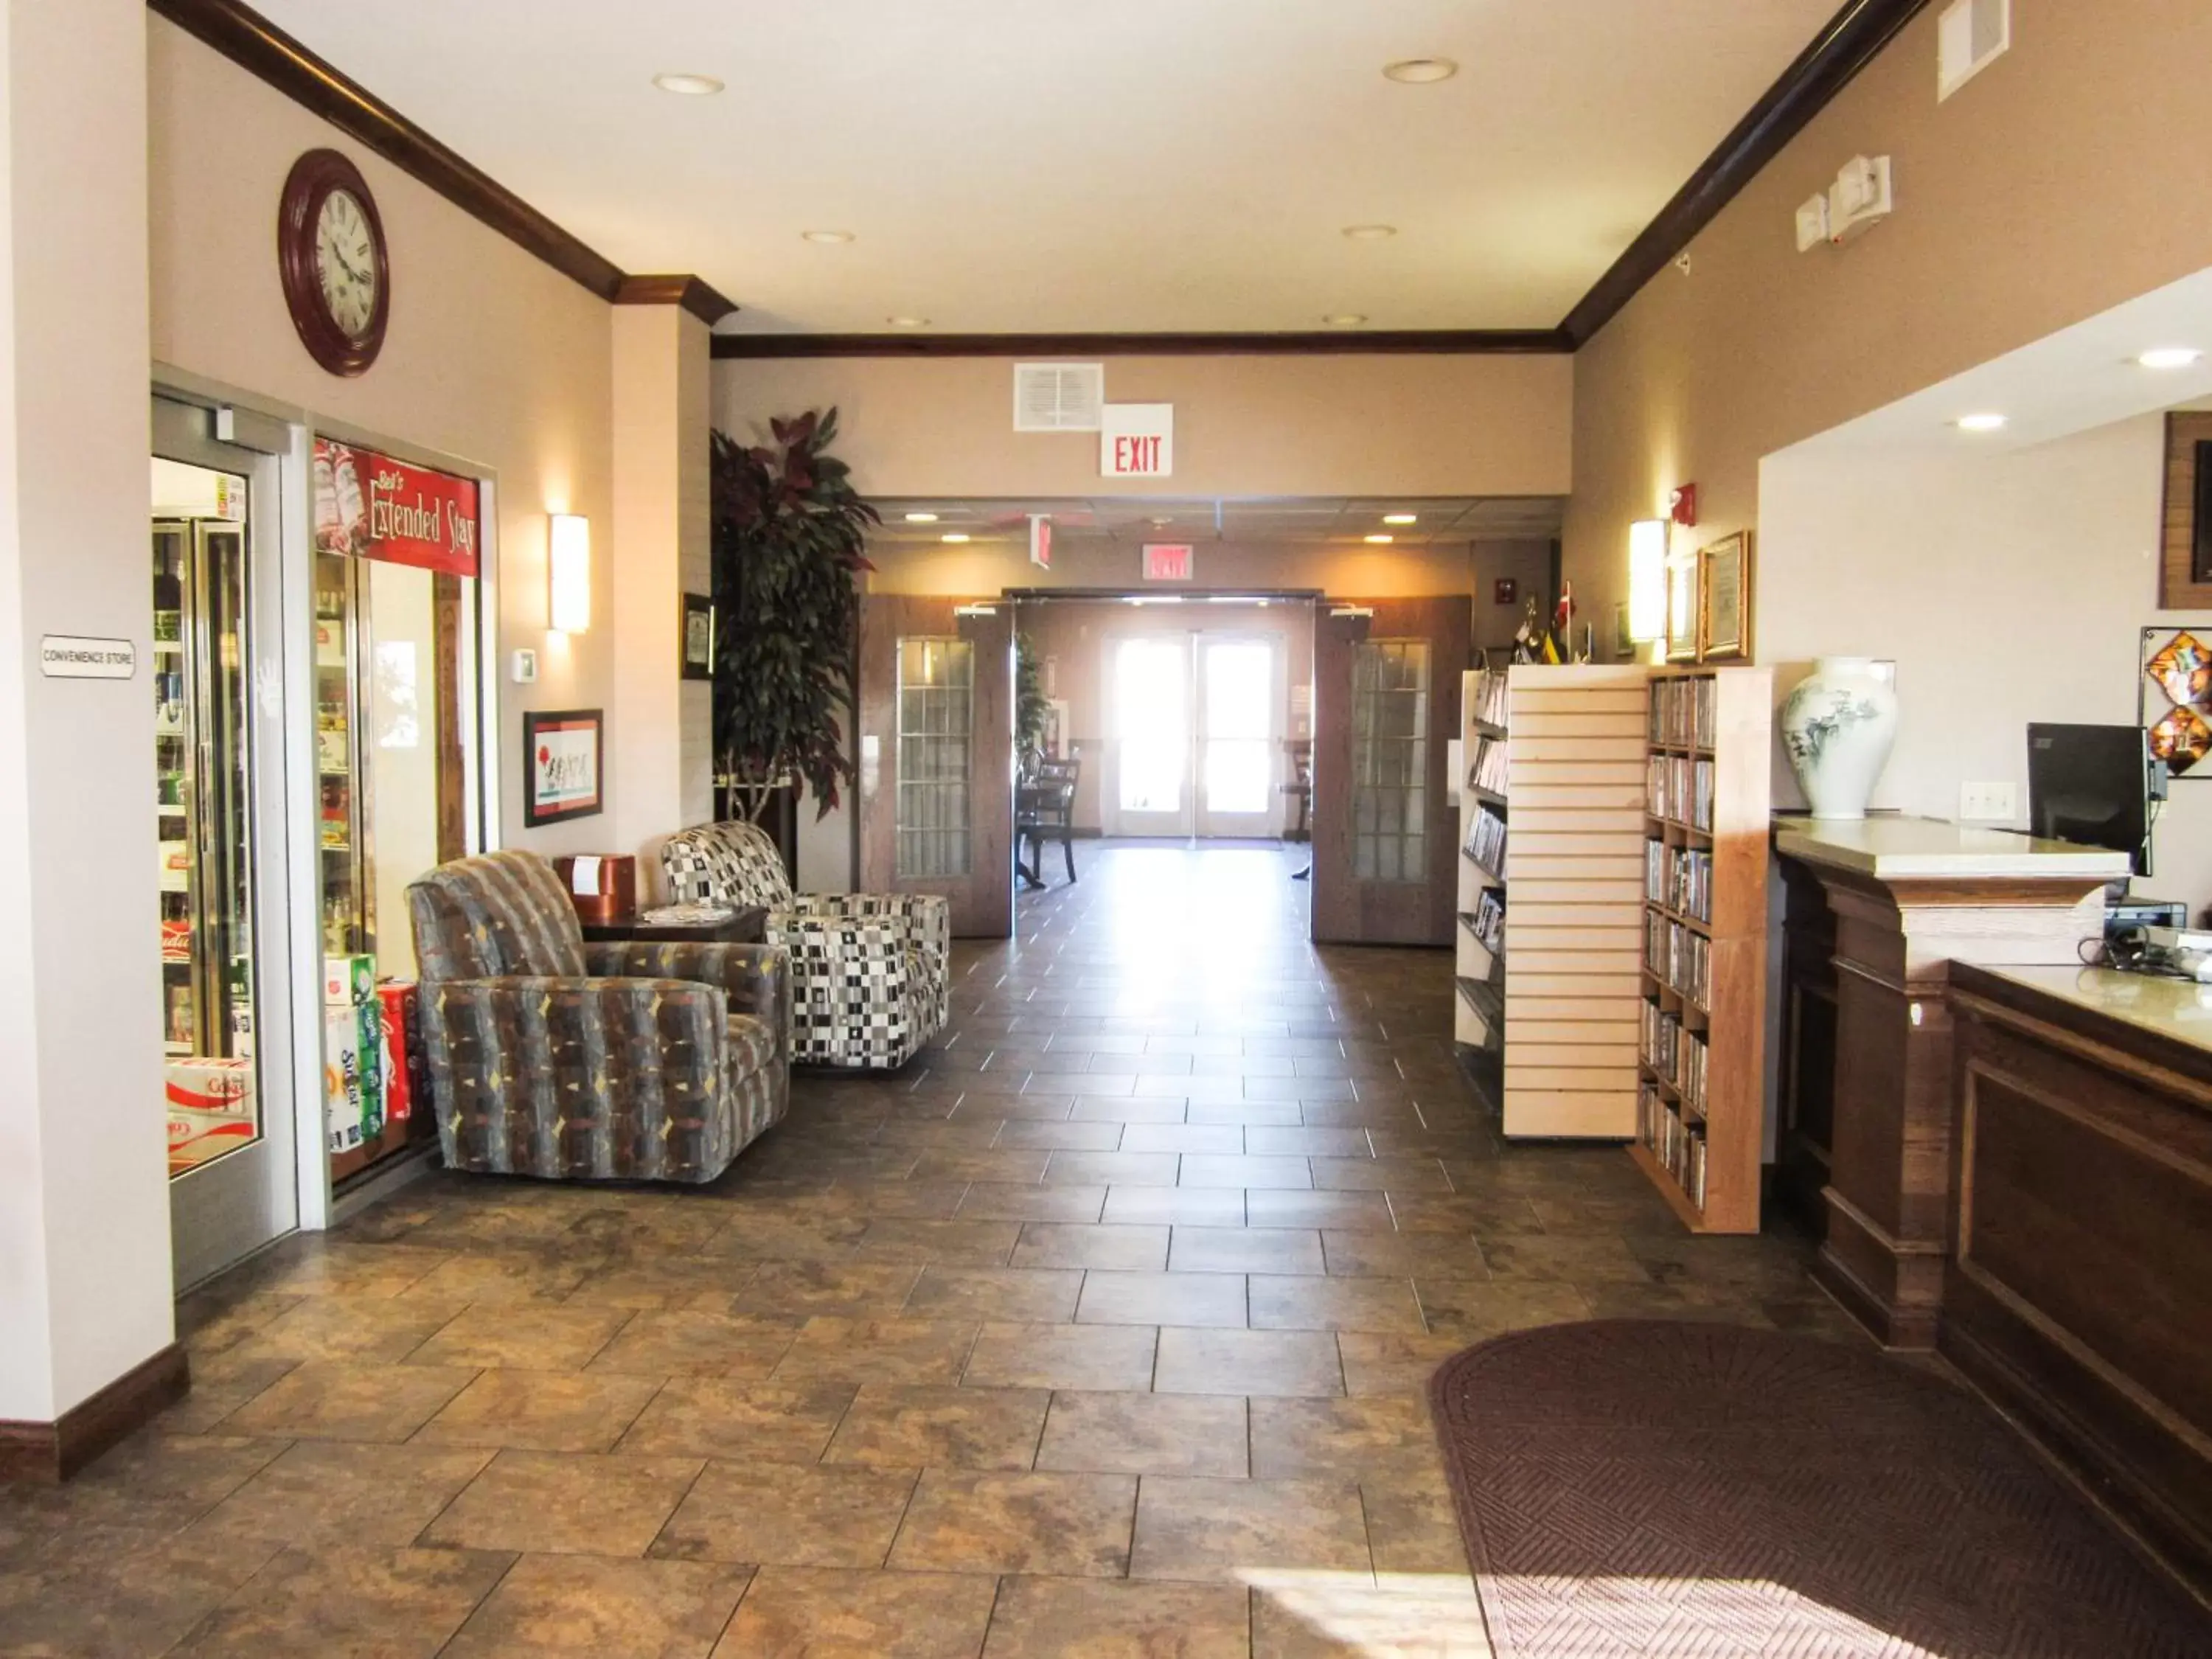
left=1938, top=967, right=2212, bottom=1586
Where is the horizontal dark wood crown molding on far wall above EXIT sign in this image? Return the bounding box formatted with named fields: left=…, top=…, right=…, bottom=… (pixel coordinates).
left=714, top=327, right=1575, bottom=358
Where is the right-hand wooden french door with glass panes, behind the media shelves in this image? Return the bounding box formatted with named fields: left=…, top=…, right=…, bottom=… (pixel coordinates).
left=1314, top=593, right=1471, bottom=945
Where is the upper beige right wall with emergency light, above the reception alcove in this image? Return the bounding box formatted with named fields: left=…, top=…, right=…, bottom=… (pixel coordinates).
left=1566, top=0, right=2212, bottom=628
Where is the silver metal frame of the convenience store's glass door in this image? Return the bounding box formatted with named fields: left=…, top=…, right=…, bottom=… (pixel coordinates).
left=148, top=389, right=303, bottom=1290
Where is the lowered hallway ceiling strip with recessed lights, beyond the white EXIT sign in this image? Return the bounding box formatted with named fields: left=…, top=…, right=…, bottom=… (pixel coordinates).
left=854, top=495, right=1566, bottom=546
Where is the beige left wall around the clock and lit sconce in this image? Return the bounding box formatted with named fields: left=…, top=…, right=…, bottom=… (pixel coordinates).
left=148, top=9, right=619, bottom=852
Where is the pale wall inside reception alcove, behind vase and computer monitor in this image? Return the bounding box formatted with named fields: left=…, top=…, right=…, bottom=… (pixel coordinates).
left=1759, top=416, right=2212, bottom=909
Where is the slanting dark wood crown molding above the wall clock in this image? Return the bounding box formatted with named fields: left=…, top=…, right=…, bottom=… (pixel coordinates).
left=146, top=0, right=624, bottom=301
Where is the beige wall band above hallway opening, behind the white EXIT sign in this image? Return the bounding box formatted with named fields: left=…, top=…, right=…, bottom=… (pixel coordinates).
left=714, top=356, right=1573, bottom=498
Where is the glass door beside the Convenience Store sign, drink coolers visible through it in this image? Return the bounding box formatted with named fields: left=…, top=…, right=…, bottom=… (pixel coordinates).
left=148, top=400, right=299, bottom=1287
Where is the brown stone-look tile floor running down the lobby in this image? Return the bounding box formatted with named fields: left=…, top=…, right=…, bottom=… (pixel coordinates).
left=0, top=845, right=1847, bottom=1659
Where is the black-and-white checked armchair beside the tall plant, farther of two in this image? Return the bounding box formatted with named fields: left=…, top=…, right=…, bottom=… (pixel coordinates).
left=661, top=823, right=953, bottom=1068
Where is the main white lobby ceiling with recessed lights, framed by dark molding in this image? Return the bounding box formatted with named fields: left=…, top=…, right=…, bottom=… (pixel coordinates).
left=257, top=0, right=1836, bottom=332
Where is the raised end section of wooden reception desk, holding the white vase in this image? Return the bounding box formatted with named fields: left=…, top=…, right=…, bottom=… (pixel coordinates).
left=1774, top=816, right=2128, bottom=1347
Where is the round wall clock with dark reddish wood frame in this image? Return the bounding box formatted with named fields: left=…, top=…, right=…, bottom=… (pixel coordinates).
left=276, top=150, right=392, bottom=374
